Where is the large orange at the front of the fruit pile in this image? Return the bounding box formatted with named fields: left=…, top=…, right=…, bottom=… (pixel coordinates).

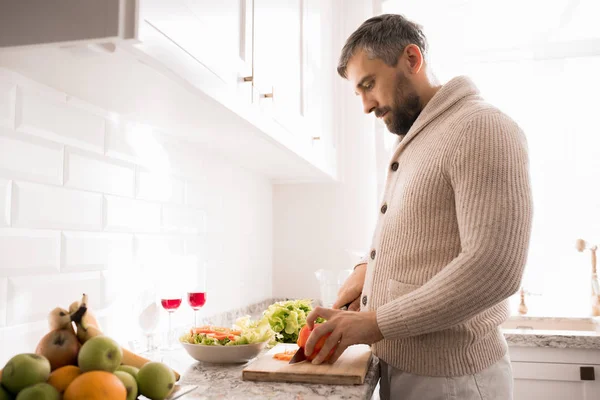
left=63, top=371, right=127, bottom=400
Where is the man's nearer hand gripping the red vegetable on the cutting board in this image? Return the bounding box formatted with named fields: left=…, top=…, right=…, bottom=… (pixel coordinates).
left=304, top=307, right=383, bottom=364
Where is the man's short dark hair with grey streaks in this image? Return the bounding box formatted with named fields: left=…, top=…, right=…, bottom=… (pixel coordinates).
left=337, top=14, right=428, bottom=78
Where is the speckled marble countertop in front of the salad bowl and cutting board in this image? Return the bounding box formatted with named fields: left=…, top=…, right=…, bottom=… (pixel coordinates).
left=153, top=349, right=379, bottom=400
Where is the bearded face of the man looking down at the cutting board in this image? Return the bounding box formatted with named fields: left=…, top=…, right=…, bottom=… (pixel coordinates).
left=346, top=51, right=422, bottom=135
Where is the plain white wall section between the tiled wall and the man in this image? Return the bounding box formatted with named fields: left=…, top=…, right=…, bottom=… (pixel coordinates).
left=273, top=0, right=378, bottom=304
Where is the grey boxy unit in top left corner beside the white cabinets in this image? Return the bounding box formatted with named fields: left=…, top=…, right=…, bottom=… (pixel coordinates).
left=0, top=0, right=137, bottom=48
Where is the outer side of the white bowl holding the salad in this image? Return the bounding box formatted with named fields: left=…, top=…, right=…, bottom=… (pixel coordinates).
left=181, top=342, right=267, bottom=364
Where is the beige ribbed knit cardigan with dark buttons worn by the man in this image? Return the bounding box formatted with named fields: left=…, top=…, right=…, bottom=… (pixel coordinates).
left=361, top=77, right=532, bottom=376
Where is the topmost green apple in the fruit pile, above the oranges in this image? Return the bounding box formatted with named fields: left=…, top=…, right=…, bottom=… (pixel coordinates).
left=77, top=336, right=123, bottom=372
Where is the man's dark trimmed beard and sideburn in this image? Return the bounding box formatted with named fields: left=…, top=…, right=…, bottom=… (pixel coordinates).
left=376, top=72, right=422, bottom=135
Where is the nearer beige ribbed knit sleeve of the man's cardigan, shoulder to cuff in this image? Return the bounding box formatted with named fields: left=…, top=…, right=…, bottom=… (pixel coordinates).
left=377, top=112, right=532, bottom=340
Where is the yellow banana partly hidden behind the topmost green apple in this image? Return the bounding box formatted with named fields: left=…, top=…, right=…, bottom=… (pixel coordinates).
left=69, top=293, right=181, bottom=381
